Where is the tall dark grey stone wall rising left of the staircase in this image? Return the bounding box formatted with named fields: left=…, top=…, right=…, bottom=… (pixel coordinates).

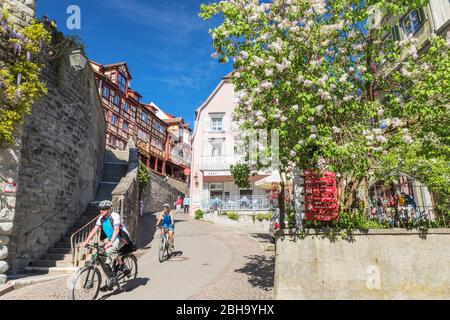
left=3, top=55, right=106, bottom=272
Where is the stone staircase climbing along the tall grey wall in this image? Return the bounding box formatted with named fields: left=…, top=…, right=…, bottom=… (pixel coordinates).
left=25, top=151, right=128, bottom=275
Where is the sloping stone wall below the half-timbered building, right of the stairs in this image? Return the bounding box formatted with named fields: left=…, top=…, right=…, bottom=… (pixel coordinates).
left=141, top=171, right=185, bottom=212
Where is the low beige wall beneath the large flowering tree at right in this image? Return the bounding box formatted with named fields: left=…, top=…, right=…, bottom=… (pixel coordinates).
left=275, top=229, right=450, bottom=300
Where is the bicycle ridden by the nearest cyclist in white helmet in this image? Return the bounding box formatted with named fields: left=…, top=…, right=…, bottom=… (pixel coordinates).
left=71, top=243, right=138, bottom=300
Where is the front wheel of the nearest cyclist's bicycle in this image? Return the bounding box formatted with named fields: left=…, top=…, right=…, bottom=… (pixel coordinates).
left=72, top=267, right=102, bottom=300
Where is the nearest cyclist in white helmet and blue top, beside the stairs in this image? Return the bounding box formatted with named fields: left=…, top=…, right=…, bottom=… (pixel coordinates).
left=81, top=200, right=133, bottom=272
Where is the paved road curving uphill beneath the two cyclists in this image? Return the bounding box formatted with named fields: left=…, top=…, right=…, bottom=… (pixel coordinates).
left=0, top=214, right=274, bottom=300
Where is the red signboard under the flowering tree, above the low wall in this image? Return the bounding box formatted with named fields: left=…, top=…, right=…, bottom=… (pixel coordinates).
left=304, top=170, right=339, bottom=221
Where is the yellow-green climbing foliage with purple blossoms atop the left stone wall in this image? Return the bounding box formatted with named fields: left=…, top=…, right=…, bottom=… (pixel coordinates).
left=0, top=11, right=50, bottom=144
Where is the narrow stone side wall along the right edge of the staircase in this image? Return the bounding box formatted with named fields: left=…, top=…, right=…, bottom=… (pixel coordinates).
left=112, top=140, right=139, bottom=243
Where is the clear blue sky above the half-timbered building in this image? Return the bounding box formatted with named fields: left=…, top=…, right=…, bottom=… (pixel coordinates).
left=37, top=0, right=232, bottom=127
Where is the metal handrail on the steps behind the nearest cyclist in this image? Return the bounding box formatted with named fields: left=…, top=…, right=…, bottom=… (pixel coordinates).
left=70, top=199, right=122, bottom=267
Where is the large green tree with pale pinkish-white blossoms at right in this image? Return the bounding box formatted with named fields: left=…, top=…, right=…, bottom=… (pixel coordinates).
left=200, top=0, right=450, bottom=225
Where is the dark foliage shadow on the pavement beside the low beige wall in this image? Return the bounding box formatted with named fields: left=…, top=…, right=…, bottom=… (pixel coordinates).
left=235, top=255, right=275, bottom=291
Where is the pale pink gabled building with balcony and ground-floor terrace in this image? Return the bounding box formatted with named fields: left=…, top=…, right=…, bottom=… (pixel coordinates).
left=190, top=74, right=270, bottom=215
